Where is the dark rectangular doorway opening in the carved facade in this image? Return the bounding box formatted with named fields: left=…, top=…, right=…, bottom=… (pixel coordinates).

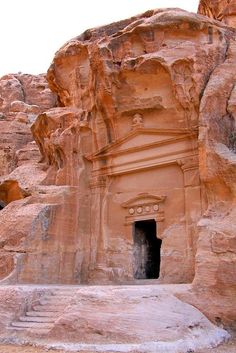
left=133, top=219, right=162, bottom=279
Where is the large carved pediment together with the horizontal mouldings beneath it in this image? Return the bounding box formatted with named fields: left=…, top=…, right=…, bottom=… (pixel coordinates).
left=86, top=127, right=198, bottom=175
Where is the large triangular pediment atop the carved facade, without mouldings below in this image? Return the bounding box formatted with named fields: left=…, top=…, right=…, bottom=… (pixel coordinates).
left=87, top=128, right=191, bottom=159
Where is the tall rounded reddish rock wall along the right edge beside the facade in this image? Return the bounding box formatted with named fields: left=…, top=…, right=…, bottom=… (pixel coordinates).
left=180, top=41, right=236, bottom=325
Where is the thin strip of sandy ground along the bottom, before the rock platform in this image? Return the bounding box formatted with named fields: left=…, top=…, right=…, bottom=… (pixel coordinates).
left=0, top=338, right=236, bottom=353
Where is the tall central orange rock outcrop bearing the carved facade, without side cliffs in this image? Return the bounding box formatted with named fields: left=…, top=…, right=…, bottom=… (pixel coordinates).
left=41, top=10, right=234, bottom=283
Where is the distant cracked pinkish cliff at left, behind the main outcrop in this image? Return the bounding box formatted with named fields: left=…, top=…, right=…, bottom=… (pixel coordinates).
left=0, top=74, right=57, bottom=176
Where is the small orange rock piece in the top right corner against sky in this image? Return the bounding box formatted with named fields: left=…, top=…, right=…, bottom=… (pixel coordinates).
left=198, top=0, right=236, bottom=28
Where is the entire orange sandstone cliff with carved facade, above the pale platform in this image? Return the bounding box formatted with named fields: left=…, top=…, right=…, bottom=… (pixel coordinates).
left=0, top=1, right=236, bottom=324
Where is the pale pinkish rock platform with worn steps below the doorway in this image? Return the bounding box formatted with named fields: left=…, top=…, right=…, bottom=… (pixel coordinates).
left=0, top=285, right=229, bottom=353
